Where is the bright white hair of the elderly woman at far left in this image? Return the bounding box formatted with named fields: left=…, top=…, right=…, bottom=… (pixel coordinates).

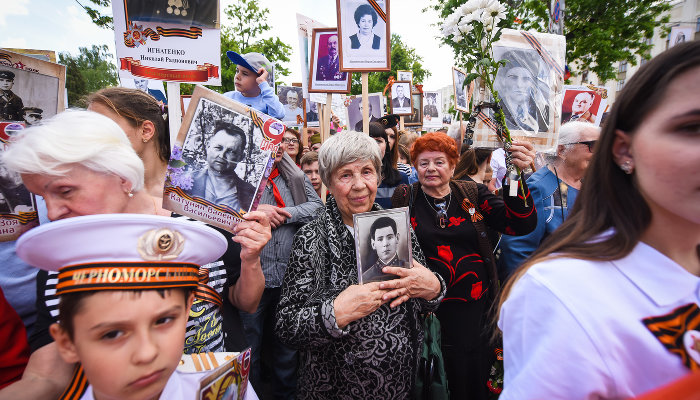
left=2, top=111, right=144, bottom=191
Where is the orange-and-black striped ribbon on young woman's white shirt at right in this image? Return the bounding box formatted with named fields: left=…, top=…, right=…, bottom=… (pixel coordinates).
left=642, top=303, right=700, bottom=371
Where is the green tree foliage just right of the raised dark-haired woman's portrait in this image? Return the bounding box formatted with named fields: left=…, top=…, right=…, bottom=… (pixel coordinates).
left=351, top=33, right=430, bottom=95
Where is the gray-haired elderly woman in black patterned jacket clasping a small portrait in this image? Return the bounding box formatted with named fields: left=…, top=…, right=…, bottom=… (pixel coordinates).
left=277, top=132, right=445, bottom=399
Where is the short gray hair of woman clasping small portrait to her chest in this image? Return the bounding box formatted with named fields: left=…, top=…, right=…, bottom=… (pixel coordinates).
left=318, top=131, right=382, bottom=187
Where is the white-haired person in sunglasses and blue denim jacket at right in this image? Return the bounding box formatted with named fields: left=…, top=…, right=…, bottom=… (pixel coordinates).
left=500, top=121, right=600, bottom=274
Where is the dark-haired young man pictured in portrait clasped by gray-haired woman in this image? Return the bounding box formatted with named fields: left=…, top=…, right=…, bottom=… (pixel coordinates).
left=362, top=217, right=408, bottom=284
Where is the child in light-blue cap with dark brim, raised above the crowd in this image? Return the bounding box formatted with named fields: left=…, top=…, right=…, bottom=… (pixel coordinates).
left=224, top=51, right=284, bottom=120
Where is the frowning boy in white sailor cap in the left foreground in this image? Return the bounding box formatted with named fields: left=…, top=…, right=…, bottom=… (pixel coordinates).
left=17, top=214, right=256, bottom=400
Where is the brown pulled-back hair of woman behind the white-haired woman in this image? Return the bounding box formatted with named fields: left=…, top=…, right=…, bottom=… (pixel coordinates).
left=87, top=87, right=170, bottom=163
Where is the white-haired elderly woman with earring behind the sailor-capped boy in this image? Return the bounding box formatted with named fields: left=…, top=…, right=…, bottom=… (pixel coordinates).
left=0, top=111, right=270, bottom=399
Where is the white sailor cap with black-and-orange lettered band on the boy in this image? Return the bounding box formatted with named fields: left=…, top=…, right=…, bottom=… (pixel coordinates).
left=16, top=214, right=228, bottom=295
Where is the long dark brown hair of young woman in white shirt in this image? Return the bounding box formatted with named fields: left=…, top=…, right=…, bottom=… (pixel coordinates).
left=498, top=42, right=700, bottom=309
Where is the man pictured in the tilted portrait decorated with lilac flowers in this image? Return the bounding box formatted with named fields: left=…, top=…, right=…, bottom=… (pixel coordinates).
left=185, top=121, right=255, bottom=211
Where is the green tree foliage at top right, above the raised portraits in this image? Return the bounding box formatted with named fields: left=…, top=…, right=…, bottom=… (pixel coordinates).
left=430, top=0, right=671, bottom=83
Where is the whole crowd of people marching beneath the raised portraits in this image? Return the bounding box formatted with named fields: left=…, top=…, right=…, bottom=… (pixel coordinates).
left=0, top=40, right=700, bottom=400
